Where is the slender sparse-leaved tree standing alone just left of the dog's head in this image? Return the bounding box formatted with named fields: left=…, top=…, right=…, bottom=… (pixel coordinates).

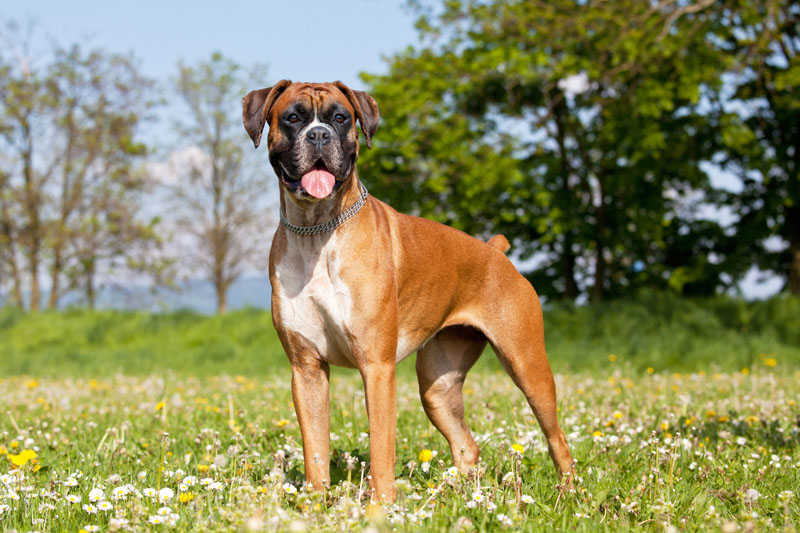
left=173, top=53, right=268, bottom=313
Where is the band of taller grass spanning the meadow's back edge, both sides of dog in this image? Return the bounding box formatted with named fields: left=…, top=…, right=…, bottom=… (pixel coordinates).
left=0, top=292, right=800, bottom=376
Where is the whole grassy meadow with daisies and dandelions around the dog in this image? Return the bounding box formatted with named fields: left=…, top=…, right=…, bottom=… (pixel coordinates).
left=0, top=295, right=800, bottom=531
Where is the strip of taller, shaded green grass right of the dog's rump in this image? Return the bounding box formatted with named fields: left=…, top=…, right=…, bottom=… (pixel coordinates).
left=545, top=292, right=800, bottom=372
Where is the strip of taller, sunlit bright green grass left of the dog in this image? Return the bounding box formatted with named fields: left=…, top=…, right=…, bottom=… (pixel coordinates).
left=0, top=309, right=286, bottom=376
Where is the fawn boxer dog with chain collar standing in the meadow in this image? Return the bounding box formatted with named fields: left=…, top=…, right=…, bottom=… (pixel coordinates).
left=242, top=80, right=573, bottom=501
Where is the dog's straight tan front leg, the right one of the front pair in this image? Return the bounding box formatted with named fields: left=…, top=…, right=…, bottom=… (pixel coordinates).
left=361, top=358, right=397, bottom=502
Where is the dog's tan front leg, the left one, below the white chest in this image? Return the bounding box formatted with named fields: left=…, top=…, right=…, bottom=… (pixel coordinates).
left=292, top=358, right=331, bottom=490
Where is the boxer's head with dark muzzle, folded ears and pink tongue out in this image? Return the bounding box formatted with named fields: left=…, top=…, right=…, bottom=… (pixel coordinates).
left=242, top=80, right=379, bottom=200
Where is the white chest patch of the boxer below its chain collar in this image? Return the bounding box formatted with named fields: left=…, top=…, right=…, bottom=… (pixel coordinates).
left=275, top=234, right=354, bottom=366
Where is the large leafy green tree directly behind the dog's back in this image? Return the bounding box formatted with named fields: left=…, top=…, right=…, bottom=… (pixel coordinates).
left=362, top=0, right=728, bottom=300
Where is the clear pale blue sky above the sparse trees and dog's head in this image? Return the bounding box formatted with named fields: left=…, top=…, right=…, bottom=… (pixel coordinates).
left=2, top=0, right=416, bottom=88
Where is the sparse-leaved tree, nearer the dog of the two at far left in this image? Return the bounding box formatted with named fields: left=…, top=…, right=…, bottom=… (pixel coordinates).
left=43, top=45, right=157, bottom=308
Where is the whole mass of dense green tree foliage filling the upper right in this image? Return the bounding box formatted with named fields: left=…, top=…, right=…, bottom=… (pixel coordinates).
left=361, top=0, right=800, bottom=300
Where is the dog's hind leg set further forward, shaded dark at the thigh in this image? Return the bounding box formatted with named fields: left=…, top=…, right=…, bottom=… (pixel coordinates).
left=417, top=327, right=486, bottom=472
